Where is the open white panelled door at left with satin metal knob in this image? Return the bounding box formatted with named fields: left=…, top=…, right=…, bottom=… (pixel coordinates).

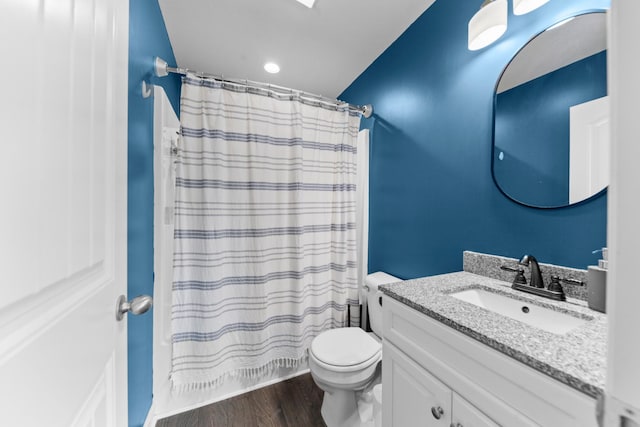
left=0, top=0, right=129, bottom=427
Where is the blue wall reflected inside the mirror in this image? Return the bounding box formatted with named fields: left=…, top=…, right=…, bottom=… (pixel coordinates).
left=493, top=52, right=607, bottom=206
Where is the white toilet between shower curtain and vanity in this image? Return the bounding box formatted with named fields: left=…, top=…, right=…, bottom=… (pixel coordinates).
left=309, top=272, right=400, bottom=427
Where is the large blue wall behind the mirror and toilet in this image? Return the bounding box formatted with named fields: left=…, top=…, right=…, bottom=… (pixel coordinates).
left=340, top=0, right=609, bottom=278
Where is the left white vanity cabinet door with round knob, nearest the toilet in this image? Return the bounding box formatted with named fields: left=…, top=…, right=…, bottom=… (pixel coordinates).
left=382, top=342, right=452, bottom=427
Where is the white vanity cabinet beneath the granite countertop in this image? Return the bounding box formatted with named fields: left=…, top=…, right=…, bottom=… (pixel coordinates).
left=382, top=296, right=597, bottom=427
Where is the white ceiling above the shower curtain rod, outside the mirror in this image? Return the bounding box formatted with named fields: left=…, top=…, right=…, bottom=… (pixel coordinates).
left=159, top=0, right=435, bottom=97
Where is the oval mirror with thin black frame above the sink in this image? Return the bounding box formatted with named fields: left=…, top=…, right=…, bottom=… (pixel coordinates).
left=492, top=12, right=609, bottom=208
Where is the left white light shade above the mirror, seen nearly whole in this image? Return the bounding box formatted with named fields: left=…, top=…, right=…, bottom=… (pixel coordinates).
left=469, top=0, right=507, bottom=50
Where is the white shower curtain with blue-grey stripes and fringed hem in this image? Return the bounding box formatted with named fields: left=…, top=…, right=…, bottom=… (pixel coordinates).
left=171, top=76, right=360, bottom=390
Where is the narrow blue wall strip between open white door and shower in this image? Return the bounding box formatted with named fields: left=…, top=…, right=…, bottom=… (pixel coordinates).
left=127, top=0, right=180, bottom=426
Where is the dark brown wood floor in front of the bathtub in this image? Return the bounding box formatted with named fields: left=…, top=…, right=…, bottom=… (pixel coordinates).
left=156, top=374, right=326, bottom=427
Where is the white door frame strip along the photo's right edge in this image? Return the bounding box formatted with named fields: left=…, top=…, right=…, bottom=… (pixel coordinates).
left=605, top=0, right=640, bottom=427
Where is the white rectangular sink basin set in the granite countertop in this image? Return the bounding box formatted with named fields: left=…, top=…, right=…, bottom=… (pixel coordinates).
left=451, top=289, right=588, bottom=335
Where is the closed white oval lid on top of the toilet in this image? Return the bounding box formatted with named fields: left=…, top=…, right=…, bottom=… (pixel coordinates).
left=311, top=328, right=382, bottom=366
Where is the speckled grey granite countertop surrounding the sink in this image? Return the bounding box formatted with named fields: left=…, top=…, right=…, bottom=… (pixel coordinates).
left=380, top=272, right=607, bottom=397
